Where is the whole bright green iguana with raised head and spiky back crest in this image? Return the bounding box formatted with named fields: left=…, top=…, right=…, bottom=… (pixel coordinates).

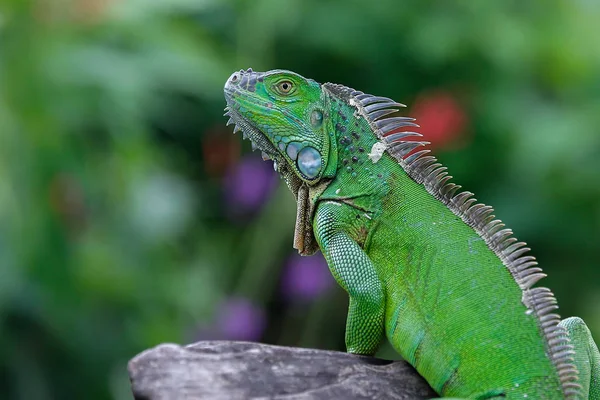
left=225, top=69, right=600, bottom=399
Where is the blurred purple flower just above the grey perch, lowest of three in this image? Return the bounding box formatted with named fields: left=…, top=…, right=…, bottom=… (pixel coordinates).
left=217, top=297, right=266, bottom=342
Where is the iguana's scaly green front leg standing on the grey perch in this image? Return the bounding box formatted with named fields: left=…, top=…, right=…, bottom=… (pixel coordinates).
left=314, top=201, right=385, bottom=355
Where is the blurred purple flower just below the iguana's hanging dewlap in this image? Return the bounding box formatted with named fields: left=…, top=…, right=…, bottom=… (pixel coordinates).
left=281, top=253, right=334, bottom=300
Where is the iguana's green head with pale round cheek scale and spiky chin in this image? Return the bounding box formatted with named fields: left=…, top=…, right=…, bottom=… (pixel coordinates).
left=225, top=68, right=336, bottom=191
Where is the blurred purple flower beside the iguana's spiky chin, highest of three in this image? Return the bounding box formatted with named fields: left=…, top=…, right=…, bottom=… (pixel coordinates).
left=223, top=156, right=277, bottom=214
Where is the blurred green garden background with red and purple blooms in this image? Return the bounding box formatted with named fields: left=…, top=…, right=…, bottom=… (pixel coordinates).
left=0, top=0, right=600, bottom=399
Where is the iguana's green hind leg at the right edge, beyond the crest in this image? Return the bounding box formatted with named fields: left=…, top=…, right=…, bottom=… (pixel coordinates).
left=560, top=317, right=600, bottom=400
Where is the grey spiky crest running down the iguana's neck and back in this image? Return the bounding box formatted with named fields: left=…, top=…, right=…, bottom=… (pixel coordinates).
left=323, top=83, right=581, bottom=399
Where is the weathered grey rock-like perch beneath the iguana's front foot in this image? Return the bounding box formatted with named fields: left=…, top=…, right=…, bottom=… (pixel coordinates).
left=129, top=341, right=436, bottom=400
